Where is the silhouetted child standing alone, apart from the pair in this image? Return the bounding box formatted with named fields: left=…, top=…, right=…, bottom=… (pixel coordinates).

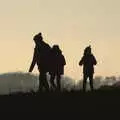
left=79, top=46, right=97, bottom=91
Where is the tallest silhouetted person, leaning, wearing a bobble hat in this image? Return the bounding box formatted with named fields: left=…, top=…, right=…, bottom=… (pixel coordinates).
left=29, top=33, right=51, bottom=91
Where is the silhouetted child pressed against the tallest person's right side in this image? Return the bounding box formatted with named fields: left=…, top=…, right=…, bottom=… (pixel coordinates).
left=50, top=45, right=66, bottom=91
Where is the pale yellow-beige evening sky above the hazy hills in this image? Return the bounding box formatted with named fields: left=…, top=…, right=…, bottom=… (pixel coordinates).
left=0, top=0, right=120, bottom=80
